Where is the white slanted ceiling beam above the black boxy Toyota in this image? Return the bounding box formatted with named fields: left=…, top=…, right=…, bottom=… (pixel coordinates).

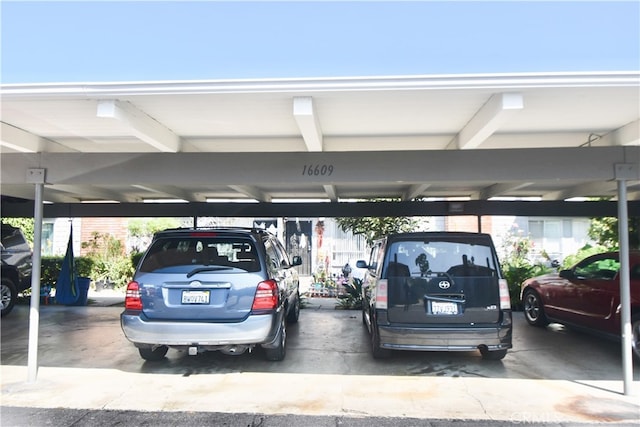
left=447, top=93, right=524, bottom=150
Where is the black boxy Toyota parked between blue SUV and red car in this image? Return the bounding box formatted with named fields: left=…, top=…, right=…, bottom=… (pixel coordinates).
left=357, top=232, right=512, bottom=360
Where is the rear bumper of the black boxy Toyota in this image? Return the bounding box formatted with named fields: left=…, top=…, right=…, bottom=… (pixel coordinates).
left=378, top=316, right=512, bottom=351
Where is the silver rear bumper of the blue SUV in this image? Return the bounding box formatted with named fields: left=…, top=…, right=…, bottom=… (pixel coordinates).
left=120, top=312, right=282, bottom=347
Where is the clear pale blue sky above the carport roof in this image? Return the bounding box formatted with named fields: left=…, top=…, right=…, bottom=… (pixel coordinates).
left=0, top=0, right=640, bottom=84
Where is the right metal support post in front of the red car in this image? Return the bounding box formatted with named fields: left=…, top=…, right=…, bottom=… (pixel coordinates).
left=618, top=179, right=633, bottom=396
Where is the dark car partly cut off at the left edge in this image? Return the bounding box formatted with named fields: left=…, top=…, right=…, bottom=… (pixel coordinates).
left=0, top=224, right=32, bottom=316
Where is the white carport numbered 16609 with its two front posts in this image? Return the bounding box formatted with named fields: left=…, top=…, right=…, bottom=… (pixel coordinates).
left=0, top=72, right=640, bottom=394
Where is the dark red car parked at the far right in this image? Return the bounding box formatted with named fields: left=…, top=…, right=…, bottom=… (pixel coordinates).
left=522, top=251, right=640, bottom=359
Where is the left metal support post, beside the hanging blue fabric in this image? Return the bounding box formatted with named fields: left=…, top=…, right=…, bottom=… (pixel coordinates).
left=27, top=180, right=44, bottom=383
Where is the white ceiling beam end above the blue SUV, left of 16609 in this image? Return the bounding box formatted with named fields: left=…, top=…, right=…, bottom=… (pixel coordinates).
left=96, top=99, right=181, bottom=153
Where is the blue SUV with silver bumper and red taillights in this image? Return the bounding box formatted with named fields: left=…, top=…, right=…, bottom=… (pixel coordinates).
left=120, top=228, right=302, bottom=360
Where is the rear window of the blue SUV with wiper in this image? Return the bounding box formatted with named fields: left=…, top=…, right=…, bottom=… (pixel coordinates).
left=140, top=236, right=260, bottom=273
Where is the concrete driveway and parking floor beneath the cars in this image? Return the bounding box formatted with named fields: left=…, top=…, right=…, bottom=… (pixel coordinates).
left=0, top=299, right=640, bottom=427
